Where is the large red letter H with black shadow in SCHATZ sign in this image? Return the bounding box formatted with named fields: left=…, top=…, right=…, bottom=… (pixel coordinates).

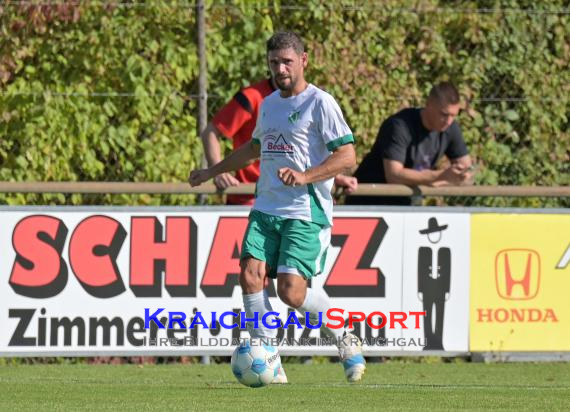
left=130, top=217, right=196, bottom=297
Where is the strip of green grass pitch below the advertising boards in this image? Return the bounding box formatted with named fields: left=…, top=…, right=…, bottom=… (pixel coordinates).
left=0, top=362, right=570, bottom=412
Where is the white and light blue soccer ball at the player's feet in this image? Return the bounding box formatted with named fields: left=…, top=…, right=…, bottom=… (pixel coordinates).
left=231, top=339, right=281, bottom=388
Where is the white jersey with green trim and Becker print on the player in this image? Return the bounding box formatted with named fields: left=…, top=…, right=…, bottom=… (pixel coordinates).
left=253, top=84, right=354, bottom=226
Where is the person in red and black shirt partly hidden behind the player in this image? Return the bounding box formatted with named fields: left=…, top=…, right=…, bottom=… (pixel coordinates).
left=200, top=79, right=352, bottom=205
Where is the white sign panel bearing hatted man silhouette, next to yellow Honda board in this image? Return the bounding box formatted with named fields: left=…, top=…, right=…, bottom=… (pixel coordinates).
left=402, top=213, right=470, bottom=352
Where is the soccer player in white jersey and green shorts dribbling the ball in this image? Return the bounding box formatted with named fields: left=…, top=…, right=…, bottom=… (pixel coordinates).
left=189, top=32, right=366, bottom=383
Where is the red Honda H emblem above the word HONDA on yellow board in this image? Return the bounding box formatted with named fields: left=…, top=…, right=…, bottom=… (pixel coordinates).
left=495, top=249, right=540, bottom=300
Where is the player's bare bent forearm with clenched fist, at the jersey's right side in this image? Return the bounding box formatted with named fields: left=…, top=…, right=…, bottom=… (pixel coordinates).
left=279, top=143, right=356, bottom=186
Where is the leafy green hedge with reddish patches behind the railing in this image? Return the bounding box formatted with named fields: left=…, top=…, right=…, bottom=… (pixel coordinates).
left=0, top=0, right=570, bottom=207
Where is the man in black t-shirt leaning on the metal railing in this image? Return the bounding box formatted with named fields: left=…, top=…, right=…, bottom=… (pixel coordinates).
left=346, top=82, right=473, bottom=205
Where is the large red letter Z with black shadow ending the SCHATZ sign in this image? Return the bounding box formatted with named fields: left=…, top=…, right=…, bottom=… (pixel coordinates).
left=324, top=218, right=388, bottom=297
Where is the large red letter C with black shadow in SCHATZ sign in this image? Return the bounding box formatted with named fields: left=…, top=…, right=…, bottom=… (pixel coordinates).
left=69, top=216, right=126, bottom=298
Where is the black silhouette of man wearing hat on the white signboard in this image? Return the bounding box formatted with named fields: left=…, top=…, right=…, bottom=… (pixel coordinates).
left=418, top=217, right=451, bottom=350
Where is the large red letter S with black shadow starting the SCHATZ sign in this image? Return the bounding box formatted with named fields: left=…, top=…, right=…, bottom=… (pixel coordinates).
left=9, top=215, right=67, bottom=298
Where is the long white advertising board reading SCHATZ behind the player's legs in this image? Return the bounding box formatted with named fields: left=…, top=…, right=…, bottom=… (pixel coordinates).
left=0, top=208, right=469, bottom=356
